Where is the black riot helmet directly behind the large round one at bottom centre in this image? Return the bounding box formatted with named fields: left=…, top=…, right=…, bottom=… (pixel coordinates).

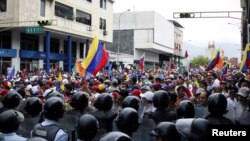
left=122, top=96, right=140, bottom=111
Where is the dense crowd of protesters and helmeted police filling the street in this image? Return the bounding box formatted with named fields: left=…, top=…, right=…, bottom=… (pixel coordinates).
left=0, top=65, right=250, bottom=141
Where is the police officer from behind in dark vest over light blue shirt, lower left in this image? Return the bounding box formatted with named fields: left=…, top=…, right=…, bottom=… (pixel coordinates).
left=32, top=97, right=69, bottom=141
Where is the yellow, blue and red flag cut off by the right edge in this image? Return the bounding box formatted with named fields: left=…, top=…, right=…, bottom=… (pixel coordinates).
left=240, top=44, right=250, bottom=72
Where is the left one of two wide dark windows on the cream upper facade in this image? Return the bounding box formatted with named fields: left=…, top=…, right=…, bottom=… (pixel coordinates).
left=55, top=2, right=74, bottom=20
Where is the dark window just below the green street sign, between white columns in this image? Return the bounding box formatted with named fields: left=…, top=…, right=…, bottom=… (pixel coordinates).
left=21, top=33, right=39, bottom=51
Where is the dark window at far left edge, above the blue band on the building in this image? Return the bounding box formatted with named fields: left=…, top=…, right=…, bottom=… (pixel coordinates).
left=0, top=31, right=11, bottom=49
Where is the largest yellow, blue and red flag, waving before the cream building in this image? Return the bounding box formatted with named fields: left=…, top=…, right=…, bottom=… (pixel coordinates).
left=82, top=37, right=108, bottom=76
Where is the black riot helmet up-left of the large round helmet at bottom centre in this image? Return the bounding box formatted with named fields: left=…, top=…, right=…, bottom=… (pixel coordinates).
left=94, top=93, right=113, bottom=111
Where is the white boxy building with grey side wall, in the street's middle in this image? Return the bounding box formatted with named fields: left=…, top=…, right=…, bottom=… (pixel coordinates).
left=111, top=11, right=183, bottom=66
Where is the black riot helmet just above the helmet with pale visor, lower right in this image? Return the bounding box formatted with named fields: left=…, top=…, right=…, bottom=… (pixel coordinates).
left=176, top=100, right=195, bottom=118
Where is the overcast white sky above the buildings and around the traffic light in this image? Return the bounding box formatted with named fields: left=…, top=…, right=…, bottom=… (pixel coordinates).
left=113, top=0, right=242, bottom=58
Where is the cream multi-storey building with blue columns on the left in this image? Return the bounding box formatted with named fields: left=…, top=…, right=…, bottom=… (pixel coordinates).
left=0, top=0, right=114, bottom=73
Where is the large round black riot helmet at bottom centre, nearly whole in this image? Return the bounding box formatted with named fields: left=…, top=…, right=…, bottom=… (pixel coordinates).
left=116, top=107, right=139, bottom=136
